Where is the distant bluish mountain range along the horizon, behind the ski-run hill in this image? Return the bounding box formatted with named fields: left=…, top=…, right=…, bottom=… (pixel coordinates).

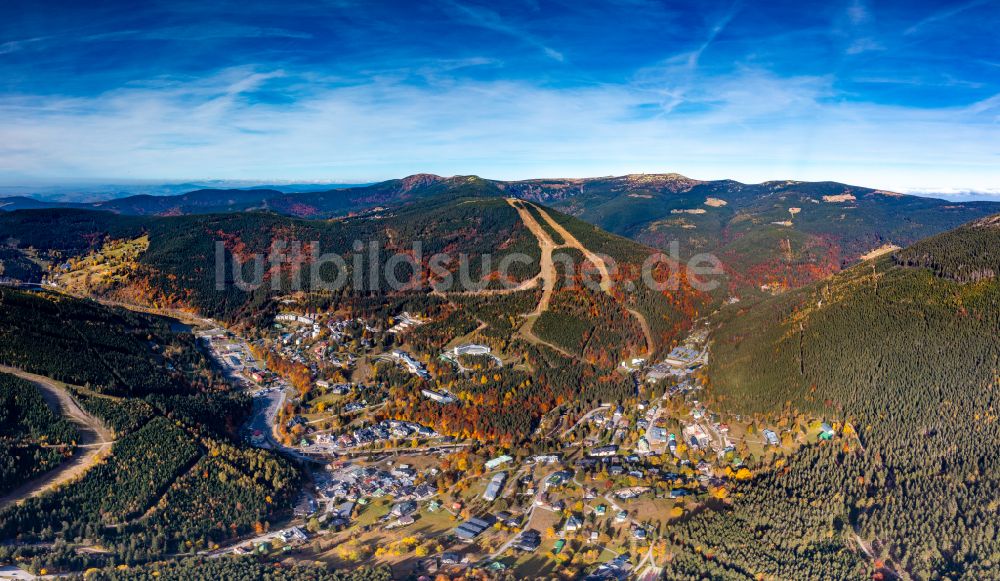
left=0, top=174, right=1000, bottom=292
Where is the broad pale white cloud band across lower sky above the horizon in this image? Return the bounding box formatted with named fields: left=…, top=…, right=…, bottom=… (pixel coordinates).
left=0, top=68, right=1000, bottom=190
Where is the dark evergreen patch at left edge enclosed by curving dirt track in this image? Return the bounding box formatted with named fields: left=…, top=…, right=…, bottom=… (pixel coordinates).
left=0, top=373, right=77, bottom=494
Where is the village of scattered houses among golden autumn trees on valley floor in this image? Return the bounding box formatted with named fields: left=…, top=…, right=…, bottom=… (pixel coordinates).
left=198, top=300, right=843, bottom=579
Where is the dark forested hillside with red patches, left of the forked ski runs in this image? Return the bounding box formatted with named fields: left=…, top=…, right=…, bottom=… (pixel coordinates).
left=0, top=195, right=539, bottom=319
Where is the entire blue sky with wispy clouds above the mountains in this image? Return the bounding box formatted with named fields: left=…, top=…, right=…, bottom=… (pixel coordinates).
left=0, top=0, right=1000, bottom=194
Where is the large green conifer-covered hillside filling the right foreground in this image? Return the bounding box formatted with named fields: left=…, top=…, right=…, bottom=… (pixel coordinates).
left=678, top=219, right=1000, bottom=579
